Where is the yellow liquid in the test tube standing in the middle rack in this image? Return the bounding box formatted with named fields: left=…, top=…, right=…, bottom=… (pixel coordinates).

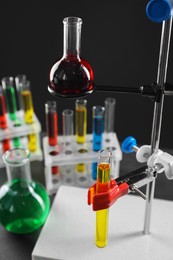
left=76, top=107, right=87, bottom=144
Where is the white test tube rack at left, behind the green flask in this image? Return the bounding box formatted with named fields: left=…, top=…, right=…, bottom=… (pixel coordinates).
left=0, top=111, right=43, bottom=168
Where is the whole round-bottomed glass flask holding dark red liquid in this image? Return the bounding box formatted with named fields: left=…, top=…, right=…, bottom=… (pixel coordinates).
left=48, top=17, right=94, bottom=98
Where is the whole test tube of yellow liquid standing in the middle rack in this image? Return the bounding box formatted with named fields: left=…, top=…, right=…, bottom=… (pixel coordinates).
left=76, top=99, right=87, bottom=144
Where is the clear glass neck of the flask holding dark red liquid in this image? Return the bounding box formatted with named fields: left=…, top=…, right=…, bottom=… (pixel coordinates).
left=63, top=17, right=82, bottom=59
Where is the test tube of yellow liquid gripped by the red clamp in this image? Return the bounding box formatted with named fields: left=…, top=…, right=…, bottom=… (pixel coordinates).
left=95, top=149, right=111, bottom=247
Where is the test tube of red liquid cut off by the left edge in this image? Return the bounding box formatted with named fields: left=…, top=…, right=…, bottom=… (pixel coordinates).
left=0, top=86, right=10, bottom=153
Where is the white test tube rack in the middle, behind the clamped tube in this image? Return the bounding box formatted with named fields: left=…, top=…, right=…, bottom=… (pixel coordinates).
left=43, top=133, right=122, bottom=194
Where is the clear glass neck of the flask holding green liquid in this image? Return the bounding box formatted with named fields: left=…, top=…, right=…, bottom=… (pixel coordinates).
left=3, top=148, right=31, bottom=182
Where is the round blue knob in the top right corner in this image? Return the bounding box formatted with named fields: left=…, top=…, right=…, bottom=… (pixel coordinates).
left=146, top=0, right=172, bottom=23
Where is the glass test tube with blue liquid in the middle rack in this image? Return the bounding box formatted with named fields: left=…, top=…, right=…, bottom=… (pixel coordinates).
left=92, top=106, right=105, bottom=151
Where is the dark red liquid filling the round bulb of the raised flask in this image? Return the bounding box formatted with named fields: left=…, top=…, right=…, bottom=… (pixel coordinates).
left=48, top=55, right=94, bottom=98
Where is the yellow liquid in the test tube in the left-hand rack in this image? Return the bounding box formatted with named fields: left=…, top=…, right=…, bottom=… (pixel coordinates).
left=21, top=90, right=34, bottom=124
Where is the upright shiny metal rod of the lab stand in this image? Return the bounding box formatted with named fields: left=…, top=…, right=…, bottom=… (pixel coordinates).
left=144, top=16, right=172, bottom=234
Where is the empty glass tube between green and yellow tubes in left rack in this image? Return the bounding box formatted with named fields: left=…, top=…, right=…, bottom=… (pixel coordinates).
left=15, top=74, right=27, bottom=111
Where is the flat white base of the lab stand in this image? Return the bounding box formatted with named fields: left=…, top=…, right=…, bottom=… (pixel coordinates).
left=32, top=186, right=173, bottom=260
